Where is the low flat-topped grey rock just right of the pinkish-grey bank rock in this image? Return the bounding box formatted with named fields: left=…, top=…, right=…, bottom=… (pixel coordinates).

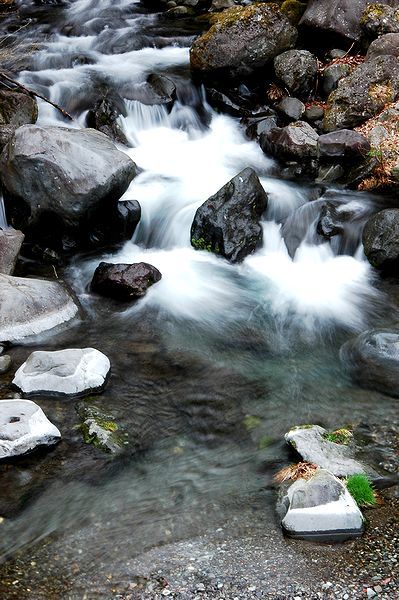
left=317, top=129, right=370, bottom=162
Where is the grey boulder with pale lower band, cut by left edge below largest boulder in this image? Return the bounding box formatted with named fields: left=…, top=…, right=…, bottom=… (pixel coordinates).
left=0, top=274, right=78, bottom=342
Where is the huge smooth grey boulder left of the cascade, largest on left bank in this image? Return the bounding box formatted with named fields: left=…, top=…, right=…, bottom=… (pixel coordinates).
left=0, top=125, right=136, bottom=250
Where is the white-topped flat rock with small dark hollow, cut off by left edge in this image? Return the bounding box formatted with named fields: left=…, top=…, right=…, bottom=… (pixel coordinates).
left=0, top=400, right=61, bottom=460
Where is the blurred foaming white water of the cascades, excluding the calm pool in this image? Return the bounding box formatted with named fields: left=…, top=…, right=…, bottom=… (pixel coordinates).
left=17, top=0, right=377, bottom=330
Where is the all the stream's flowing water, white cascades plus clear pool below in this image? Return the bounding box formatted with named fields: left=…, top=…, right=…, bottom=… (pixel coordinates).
left=0, top=0, right=397, bottom=592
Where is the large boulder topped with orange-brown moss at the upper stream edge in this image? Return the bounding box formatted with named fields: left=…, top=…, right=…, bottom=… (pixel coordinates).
left=190, top=3, right=297, bottom=76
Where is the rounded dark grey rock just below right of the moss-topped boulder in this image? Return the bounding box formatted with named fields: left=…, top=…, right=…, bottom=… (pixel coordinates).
left=274, top=50, right=317, bottom=99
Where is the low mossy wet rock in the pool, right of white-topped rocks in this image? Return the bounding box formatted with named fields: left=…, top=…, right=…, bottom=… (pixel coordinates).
left=76, top=403, right=129, bottom=454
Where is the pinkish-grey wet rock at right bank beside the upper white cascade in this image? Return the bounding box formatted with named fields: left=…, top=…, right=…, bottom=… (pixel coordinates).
left=259, top=121, right=319, bottom=160
